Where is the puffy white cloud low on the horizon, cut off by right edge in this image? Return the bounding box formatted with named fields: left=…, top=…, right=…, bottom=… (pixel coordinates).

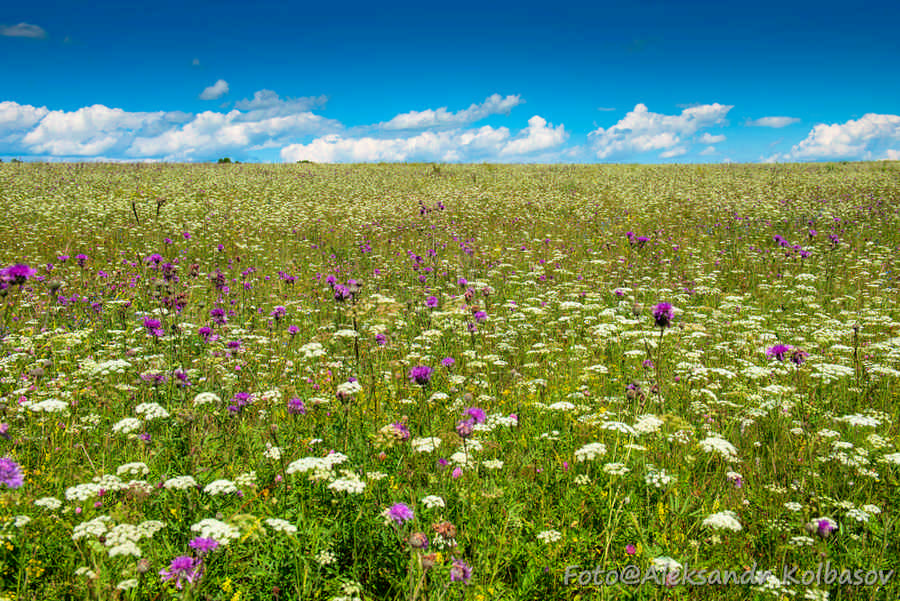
left=786, top=113, right=900, bottom=160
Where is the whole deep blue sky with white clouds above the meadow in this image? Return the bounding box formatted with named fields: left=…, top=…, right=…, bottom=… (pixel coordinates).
left=0, top=0, right=900, bottom=163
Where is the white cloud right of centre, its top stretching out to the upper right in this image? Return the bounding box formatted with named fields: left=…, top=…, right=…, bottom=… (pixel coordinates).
left=588, top=103, right=733, bottom=159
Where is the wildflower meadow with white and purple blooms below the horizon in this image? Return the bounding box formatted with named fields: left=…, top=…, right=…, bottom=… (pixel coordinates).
left=0, top=162, right=900, bottom=601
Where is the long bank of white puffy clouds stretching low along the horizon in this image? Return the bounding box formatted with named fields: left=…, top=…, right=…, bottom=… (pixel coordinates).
left=0, top=89, right=900, bottom=163
